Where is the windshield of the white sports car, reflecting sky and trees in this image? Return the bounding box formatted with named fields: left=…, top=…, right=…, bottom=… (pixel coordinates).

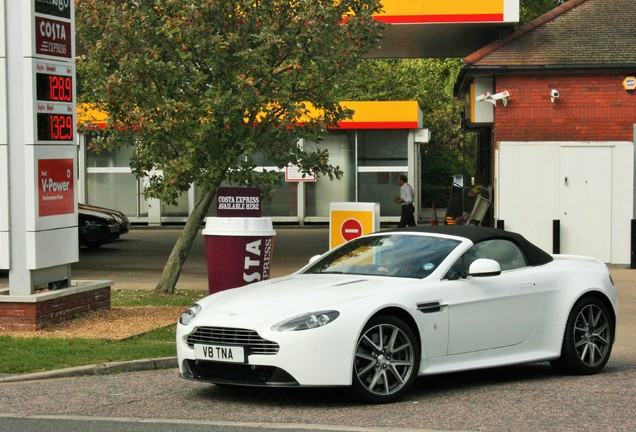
left=304, top=234, right=460, bottom=279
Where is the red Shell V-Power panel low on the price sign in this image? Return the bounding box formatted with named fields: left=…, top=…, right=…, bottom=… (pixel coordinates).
left=38, top=159, right=75, bottom=217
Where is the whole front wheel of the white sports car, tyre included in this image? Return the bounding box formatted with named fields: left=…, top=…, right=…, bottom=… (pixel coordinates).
left=353, top=316, right=420, bottom=403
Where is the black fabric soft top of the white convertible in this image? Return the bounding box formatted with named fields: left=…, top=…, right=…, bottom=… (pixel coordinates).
left=389, top=225, right=553, bottom=266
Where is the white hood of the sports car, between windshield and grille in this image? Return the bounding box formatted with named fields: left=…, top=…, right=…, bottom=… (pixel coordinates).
left=195, top=274, right=414, bottom=328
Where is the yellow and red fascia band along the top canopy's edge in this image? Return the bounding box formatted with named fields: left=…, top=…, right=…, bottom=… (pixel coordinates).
left=376, top=0, right=506, bottom=24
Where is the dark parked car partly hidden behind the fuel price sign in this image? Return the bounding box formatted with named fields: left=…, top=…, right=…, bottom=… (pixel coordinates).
left=78, top=204, right=130, bottom=249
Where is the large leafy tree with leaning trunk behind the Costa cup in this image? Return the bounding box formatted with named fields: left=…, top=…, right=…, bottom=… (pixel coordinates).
left=76, top=0, right=381, bottom=293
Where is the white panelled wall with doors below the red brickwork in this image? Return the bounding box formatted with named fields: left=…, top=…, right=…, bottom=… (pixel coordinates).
left=495, top=142, right=634, bottom=264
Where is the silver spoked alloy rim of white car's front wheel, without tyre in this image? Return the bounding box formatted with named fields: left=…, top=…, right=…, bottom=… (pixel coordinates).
left=354, top=324, right=415, bottom=395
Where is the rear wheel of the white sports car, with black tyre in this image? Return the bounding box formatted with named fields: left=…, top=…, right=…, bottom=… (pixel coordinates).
left=550, top=297, right=614, bottom=375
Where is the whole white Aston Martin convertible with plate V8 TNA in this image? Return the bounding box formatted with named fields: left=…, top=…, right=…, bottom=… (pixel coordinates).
left=177, top=226, right=618, bottom=403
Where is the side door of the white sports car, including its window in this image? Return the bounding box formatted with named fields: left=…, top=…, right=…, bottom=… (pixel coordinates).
left=446, top=239, right=541, bottom=355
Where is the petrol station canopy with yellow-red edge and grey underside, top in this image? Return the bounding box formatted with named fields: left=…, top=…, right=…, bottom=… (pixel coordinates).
left=369, top=0, right=519, bottom=58
